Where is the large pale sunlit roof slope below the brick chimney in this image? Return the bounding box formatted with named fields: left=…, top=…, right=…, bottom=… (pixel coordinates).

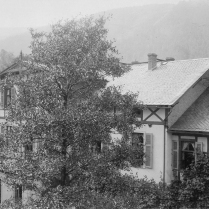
left=110, top=58, right=209, bottom=105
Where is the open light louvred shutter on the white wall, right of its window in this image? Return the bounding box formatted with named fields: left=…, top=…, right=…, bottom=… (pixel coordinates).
left=145, top=133, right=153, bottom=168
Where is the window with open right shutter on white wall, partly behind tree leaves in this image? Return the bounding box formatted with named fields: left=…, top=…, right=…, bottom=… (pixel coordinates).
left=132, top=133, right=153, bottom=168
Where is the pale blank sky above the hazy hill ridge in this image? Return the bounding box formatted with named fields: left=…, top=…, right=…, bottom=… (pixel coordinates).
left=0, top=0, right=186, bottom=28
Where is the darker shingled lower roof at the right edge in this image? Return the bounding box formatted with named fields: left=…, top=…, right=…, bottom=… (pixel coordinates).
left=169, top=88, right=209, bottom=132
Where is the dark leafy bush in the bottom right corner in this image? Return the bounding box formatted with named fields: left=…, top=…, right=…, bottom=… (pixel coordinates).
left=161, top=155, right=209, bottom=208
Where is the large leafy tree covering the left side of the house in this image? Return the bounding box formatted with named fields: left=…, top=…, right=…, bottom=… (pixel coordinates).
left=0, top=17, right=143, bottom=208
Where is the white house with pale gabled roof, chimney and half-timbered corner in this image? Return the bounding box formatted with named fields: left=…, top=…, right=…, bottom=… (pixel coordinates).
left=112, top=53, right=209, bottom=183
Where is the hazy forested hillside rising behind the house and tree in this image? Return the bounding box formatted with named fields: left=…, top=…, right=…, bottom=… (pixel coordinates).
left=0, top=0, right=209, bottom=62
